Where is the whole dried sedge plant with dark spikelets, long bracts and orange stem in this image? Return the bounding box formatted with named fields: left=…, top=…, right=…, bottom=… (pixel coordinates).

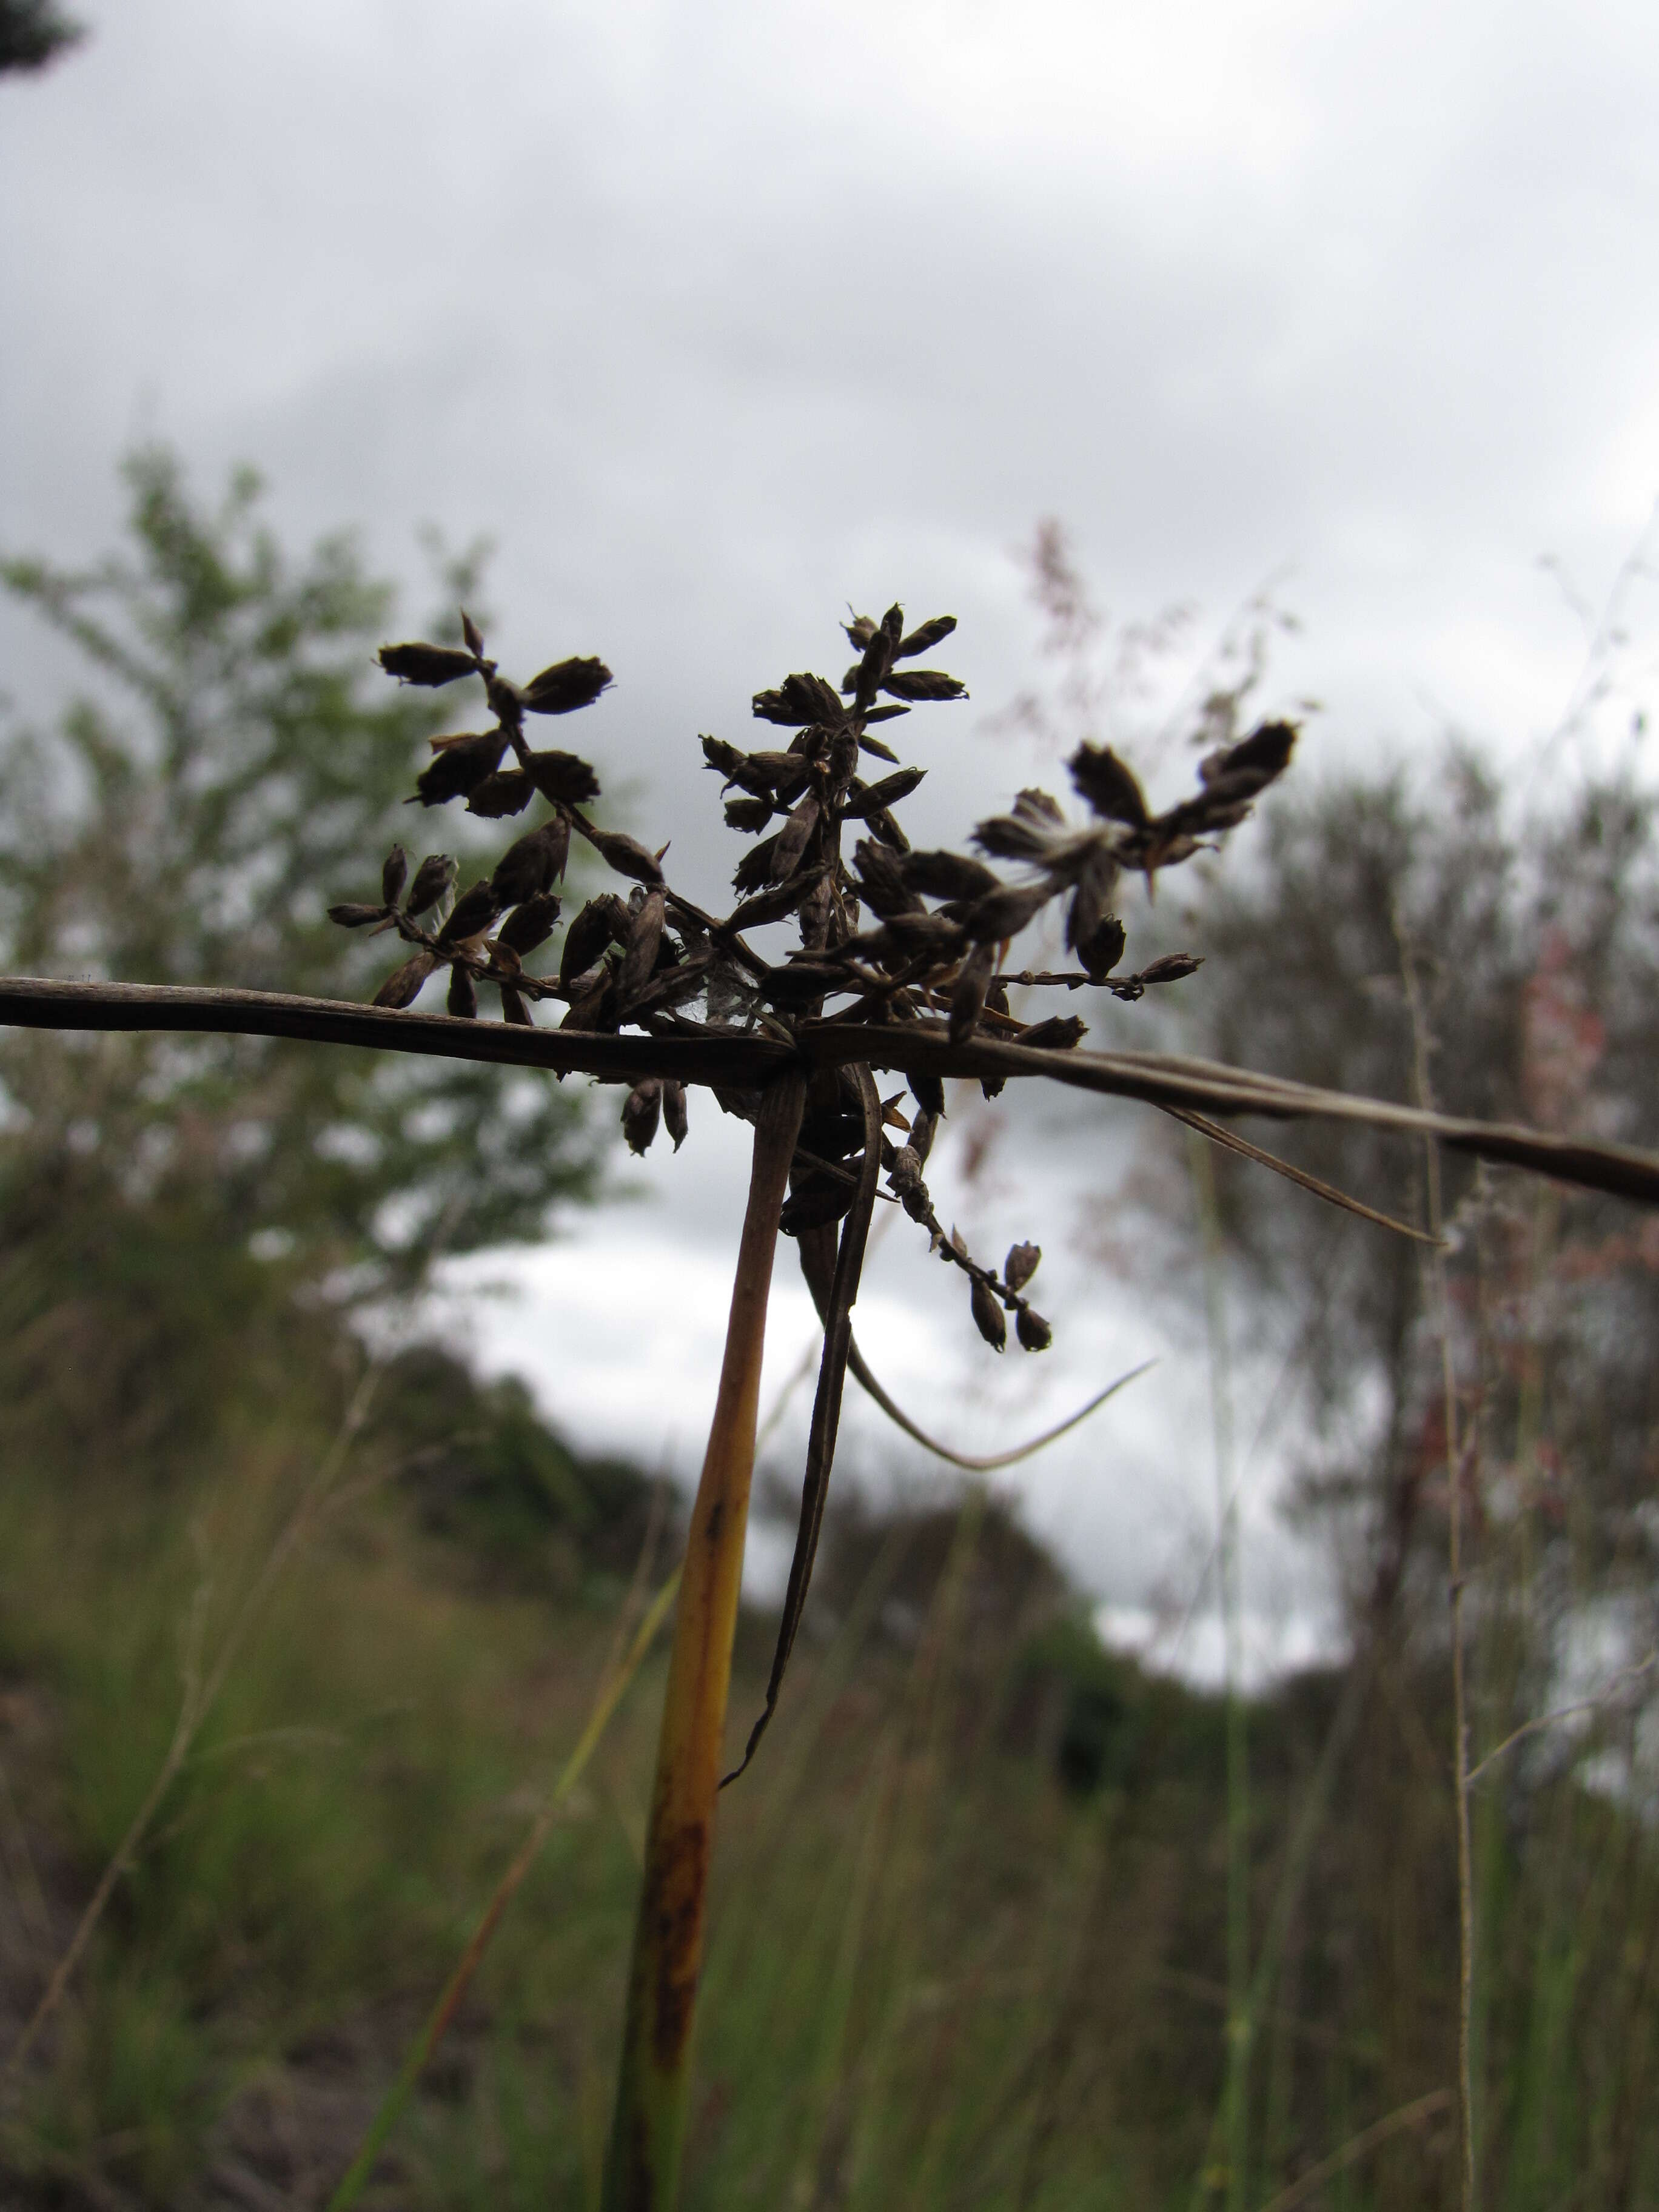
left=0, top=606, right=1659, bottom=2212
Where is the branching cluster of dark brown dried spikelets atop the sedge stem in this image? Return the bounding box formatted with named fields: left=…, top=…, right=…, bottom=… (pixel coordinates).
left=347, top=606, right=1296, bottom=1352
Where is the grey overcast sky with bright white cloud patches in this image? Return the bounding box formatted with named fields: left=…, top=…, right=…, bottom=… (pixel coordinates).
left=0, top=0, right=1659, bottom=1672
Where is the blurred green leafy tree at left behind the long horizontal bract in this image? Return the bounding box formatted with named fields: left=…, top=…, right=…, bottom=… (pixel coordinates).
left=0, top=451, right=591, bottom=1290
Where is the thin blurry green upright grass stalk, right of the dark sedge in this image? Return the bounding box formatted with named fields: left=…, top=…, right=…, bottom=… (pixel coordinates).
left=1188, top=1133, right=1252, bottom=2212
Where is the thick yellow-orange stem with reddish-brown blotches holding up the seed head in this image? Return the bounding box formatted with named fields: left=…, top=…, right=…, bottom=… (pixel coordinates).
left=604, top=1071, right=805, bottom=2212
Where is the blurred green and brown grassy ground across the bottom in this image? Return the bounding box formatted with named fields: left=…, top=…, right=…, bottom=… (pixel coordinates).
left=0, top=1336, right=1659, bottom=2212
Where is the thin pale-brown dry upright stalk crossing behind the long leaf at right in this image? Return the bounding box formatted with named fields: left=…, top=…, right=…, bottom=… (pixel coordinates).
left=1393, top=911, right=1480, bottom=2212
